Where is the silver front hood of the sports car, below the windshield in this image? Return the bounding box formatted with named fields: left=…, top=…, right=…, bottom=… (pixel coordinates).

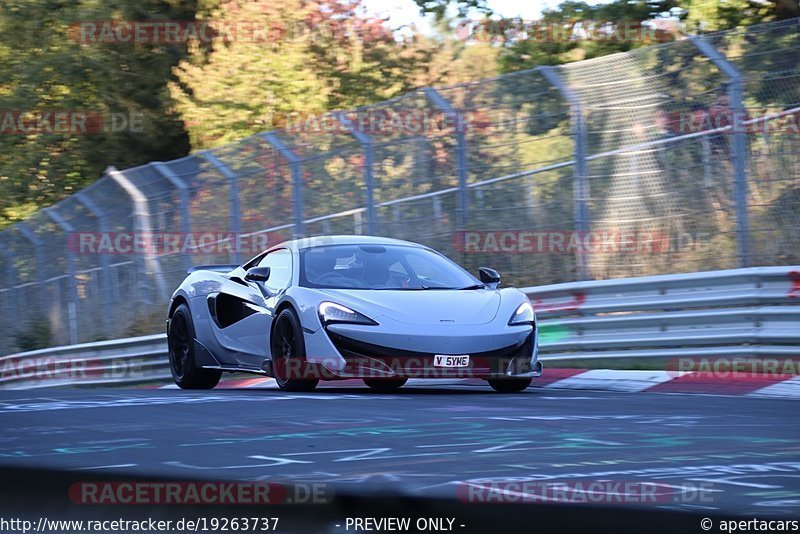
left=318, top=289, right=501, bottom=326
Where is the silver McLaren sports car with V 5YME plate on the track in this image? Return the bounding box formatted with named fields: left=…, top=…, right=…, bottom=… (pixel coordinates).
left=167, top=236, right=542, bottom=392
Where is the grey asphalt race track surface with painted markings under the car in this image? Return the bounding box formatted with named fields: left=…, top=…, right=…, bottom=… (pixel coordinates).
left=0, top=386, right=800, bottom=519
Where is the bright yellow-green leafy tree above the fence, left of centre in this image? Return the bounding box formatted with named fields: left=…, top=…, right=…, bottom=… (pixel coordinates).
left=170, top=0, right=402, bottom=149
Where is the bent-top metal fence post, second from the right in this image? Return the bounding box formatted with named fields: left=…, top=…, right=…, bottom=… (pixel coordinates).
left=539, top=67, right=590, bottom=280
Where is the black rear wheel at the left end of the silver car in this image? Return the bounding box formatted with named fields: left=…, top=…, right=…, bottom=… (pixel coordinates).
left=167, top=304, right=222, bottom=389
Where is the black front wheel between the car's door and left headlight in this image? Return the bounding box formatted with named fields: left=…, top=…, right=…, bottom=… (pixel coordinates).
left=270, top=308, right=319, bottom=391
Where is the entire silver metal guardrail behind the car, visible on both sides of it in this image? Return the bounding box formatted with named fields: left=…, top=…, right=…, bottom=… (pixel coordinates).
left=0, top=266, right=800, bottom=389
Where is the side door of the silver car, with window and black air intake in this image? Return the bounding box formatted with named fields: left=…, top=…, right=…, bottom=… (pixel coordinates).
left=214, top=249, right=292, bottom=369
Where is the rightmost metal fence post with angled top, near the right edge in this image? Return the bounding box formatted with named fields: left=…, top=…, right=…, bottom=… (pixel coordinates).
left=690, top=36, right=751, bottom=267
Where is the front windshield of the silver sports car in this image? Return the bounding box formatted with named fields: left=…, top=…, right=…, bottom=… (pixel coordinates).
left=300, top=245, right=483, bottom=290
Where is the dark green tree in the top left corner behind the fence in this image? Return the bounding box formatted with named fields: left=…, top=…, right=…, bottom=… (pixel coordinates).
left=0, top=0, right=195, bottom=226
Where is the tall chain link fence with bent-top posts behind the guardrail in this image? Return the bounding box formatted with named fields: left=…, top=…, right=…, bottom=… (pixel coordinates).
left=0, top=20, right=800, bottom=353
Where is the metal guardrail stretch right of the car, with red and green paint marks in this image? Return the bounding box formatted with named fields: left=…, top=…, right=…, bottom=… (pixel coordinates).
left=526, top=267, right=800, bottom=361
